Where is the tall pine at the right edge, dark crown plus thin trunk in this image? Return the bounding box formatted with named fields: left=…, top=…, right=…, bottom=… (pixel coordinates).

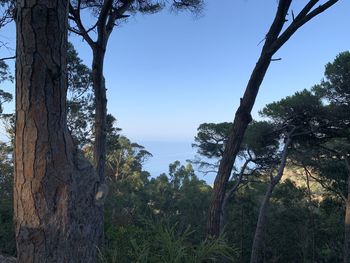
left=313, top=51, right=350, bottom=263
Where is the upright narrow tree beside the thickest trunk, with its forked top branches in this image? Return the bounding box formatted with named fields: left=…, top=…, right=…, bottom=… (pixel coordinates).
left=69, top=0, right=203, bottom=185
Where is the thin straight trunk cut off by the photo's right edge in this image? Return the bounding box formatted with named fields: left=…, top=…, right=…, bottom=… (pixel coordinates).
left=344, top=156, right=350, bottom=263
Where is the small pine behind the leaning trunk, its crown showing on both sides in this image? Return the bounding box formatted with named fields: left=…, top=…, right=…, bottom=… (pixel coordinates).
left=192, top=121, right=279, bottom=229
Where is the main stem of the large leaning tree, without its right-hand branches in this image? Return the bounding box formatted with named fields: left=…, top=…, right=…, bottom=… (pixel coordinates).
left=207, top=0, right=291, bottom=237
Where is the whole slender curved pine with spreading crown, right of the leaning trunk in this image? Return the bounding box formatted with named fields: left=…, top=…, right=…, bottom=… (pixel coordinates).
left=250, top=90, right=324, bottom=263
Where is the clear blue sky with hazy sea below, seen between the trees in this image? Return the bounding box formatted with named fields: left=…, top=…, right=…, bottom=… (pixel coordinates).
left=0, top=0, right=350, bottom=181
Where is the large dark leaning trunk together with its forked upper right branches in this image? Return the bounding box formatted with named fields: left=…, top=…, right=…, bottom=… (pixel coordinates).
left=207, top=0, right=338, bottom=237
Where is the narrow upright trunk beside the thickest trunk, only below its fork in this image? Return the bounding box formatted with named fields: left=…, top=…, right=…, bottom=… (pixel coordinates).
left=92, top=45, right=107, bottom=182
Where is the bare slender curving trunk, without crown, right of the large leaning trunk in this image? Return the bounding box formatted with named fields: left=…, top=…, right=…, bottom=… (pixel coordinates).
left=250, top=134, right=292, bottom=263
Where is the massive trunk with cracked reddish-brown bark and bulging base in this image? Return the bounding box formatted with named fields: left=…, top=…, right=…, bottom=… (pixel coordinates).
left=14, top=0, right=103, bottom=263
